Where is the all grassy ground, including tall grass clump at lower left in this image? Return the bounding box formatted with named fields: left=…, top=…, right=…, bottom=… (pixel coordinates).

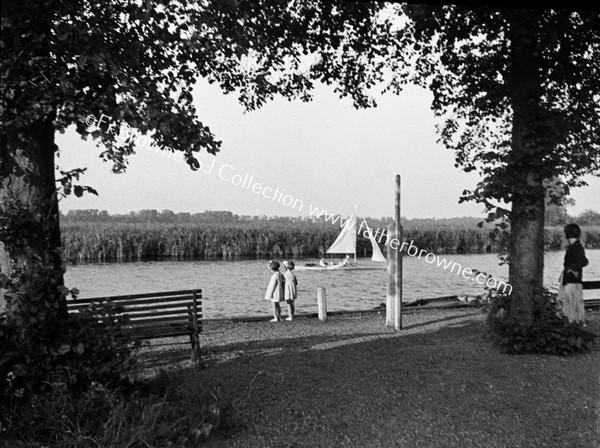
left=7, top=307, right=600, bottom=448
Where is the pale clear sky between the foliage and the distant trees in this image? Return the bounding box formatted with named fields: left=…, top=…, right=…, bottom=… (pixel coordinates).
left=56, top=81, right=600, bottom=219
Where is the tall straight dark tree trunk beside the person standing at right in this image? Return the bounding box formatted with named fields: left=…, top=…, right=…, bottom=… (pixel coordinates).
left=507, top=10, right=545, bottom=323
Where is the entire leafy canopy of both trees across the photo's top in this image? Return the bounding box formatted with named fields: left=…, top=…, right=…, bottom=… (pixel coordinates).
left=0, top=0, right=600, bottom=218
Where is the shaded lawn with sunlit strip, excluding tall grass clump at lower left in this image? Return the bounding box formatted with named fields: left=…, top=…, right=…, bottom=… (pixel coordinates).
left=141, top=308, right=600, bottom=448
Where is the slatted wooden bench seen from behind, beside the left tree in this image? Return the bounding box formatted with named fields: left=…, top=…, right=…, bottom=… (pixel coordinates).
left=67, top=289, right=202, bottom=361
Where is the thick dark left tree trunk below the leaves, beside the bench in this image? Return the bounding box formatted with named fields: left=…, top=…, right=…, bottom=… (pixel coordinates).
left=0, top=118, right=66, bottom=321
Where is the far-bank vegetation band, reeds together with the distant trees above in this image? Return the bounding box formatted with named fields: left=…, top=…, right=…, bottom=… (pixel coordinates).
left=62, top=210, right=600, bottom=263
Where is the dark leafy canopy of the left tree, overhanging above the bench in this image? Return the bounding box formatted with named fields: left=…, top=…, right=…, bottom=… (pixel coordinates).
left=0, top=0, right=394, bottom=173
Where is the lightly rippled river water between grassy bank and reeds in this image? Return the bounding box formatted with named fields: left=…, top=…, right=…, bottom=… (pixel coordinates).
left=65, top=250, right=600, bottom=318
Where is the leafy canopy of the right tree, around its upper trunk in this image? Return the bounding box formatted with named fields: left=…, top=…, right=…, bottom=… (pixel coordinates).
left=384, top=5, right=600, bottom=219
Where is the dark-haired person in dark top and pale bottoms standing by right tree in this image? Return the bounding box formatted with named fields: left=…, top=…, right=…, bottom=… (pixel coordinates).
left=558, top=224, right=588, bottom=323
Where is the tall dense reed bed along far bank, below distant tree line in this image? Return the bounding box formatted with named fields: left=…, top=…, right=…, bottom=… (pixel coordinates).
left=62, top=220, right=600, bottom=264
